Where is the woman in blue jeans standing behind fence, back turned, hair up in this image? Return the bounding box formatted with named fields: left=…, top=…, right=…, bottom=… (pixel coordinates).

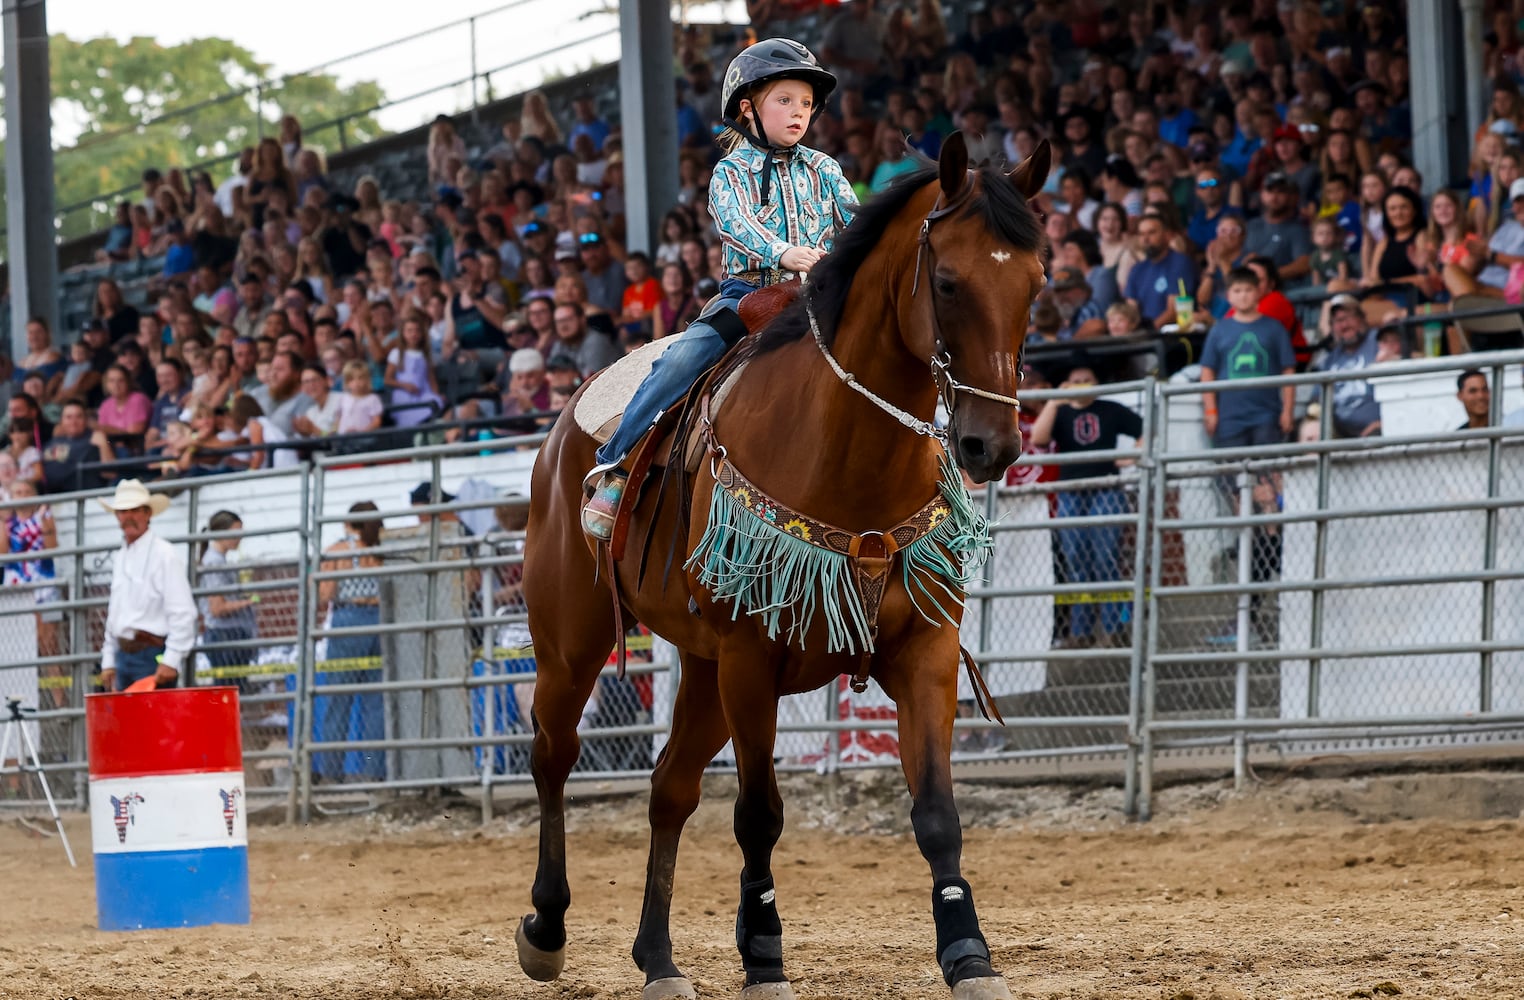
left=312, top=500, right=386, bottom=782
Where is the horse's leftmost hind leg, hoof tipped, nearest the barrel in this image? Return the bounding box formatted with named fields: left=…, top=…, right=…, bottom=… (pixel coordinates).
left=515, top=582, right=614, bottom=982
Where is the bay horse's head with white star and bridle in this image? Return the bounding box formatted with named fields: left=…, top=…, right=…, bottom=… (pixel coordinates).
left=901, top=133, right=1050, bottom=483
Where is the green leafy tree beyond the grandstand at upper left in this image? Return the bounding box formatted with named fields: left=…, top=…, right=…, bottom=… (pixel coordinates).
left=0, top=35, right=384, bottom=239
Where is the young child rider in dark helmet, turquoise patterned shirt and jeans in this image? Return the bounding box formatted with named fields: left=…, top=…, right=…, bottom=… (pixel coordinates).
left=582, top=38, right=856, bottom=540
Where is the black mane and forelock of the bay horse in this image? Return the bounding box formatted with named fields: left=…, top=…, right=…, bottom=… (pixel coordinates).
left=745, top=157, right=1042, bottom=357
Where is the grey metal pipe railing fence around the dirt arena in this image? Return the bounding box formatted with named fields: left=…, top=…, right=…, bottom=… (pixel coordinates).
left=0, top=352, right=1524, bottom=819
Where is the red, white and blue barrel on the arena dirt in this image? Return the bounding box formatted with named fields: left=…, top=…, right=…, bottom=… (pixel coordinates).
left=85, top=688, right=248, bottom=930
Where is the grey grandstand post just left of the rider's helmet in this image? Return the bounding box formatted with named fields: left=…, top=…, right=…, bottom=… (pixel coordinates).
left=619, top=0, right=678, bottom=253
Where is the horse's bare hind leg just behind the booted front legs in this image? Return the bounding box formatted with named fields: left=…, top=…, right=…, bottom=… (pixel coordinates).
left=631, top=654, right=727, bottom=1000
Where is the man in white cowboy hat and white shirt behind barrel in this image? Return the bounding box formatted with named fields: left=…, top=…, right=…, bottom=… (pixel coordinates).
left=101, top=479, right=197, bottom=691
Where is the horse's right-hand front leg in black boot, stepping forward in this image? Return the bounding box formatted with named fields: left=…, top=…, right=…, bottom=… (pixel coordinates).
left=873, top=627, right=1010, bottom=1000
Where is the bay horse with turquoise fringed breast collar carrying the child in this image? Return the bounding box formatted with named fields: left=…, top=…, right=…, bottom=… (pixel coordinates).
left=515, top=134, right=1050, bottom=1000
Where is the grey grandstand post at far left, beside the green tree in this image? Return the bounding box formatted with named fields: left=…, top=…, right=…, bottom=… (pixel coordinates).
left=3, top=0, right=58, bottom=358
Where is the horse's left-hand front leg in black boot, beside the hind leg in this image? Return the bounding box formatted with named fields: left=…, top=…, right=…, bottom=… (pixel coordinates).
left=719, top=636, right=794, bottom=1000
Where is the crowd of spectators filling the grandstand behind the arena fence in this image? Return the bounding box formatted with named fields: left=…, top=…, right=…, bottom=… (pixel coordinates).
left=6, top=0, right=1524, bottom=512
